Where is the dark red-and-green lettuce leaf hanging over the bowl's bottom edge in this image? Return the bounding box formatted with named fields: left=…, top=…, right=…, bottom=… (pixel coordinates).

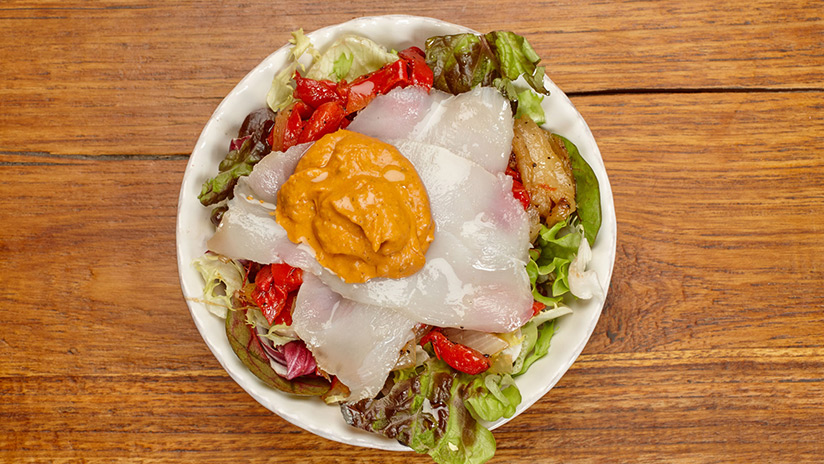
left=341, top=359, right=495, bottom=464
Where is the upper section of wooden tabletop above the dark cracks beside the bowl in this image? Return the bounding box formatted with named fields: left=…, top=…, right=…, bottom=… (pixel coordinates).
left=0, top=0, right=824, bottom=154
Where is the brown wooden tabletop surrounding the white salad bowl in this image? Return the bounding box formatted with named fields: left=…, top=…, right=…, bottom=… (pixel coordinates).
left=0, top=0, right=824, bottom=464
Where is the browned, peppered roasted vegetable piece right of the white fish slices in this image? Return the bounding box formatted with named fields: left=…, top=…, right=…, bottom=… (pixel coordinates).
left=512, top=116, right=576, bottom=227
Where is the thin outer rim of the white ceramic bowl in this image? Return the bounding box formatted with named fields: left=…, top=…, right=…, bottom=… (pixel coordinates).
left=175, top=14, right=617, bottom=451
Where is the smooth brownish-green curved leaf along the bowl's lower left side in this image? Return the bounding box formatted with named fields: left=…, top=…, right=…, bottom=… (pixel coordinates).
left=226, top=310, right=330, bottom=396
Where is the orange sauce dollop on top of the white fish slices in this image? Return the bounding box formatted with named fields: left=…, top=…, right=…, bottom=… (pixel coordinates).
left=275, top=130, right=435, bottom=283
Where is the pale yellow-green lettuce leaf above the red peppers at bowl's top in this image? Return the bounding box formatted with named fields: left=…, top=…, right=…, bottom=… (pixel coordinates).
left=306, top=35, right=398, bottom=81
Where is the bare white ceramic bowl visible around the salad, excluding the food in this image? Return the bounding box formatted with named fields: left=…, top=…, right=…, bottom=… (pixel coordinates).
left=177, top=15, right=616, bottom=450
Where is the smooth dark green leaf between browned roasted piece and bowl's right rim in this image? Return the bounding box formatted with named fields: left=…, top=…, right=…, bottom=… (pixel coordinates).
left=553, top=134, right=601, bottom=245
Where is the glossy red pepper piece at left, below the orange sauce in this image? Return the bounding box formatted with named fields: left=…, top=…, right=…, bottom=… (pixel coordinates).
left=252, top=264, right=303, bottom=324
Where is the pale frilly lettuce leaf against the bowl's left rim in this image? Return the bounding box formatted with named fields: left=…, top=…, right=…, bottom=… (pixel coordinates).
left=192, top=253, right=243, bottom=318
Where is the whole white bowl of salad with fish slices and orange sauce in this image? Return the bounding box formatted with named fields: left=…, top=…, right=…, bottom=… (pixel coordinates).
left=178, top=16, right=615, bottom=463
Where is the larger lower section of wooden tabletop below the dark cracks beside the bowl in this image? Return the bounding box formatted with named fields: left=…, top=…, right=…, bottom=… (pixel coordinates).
left=0, top=89, right=824, bottom=463
